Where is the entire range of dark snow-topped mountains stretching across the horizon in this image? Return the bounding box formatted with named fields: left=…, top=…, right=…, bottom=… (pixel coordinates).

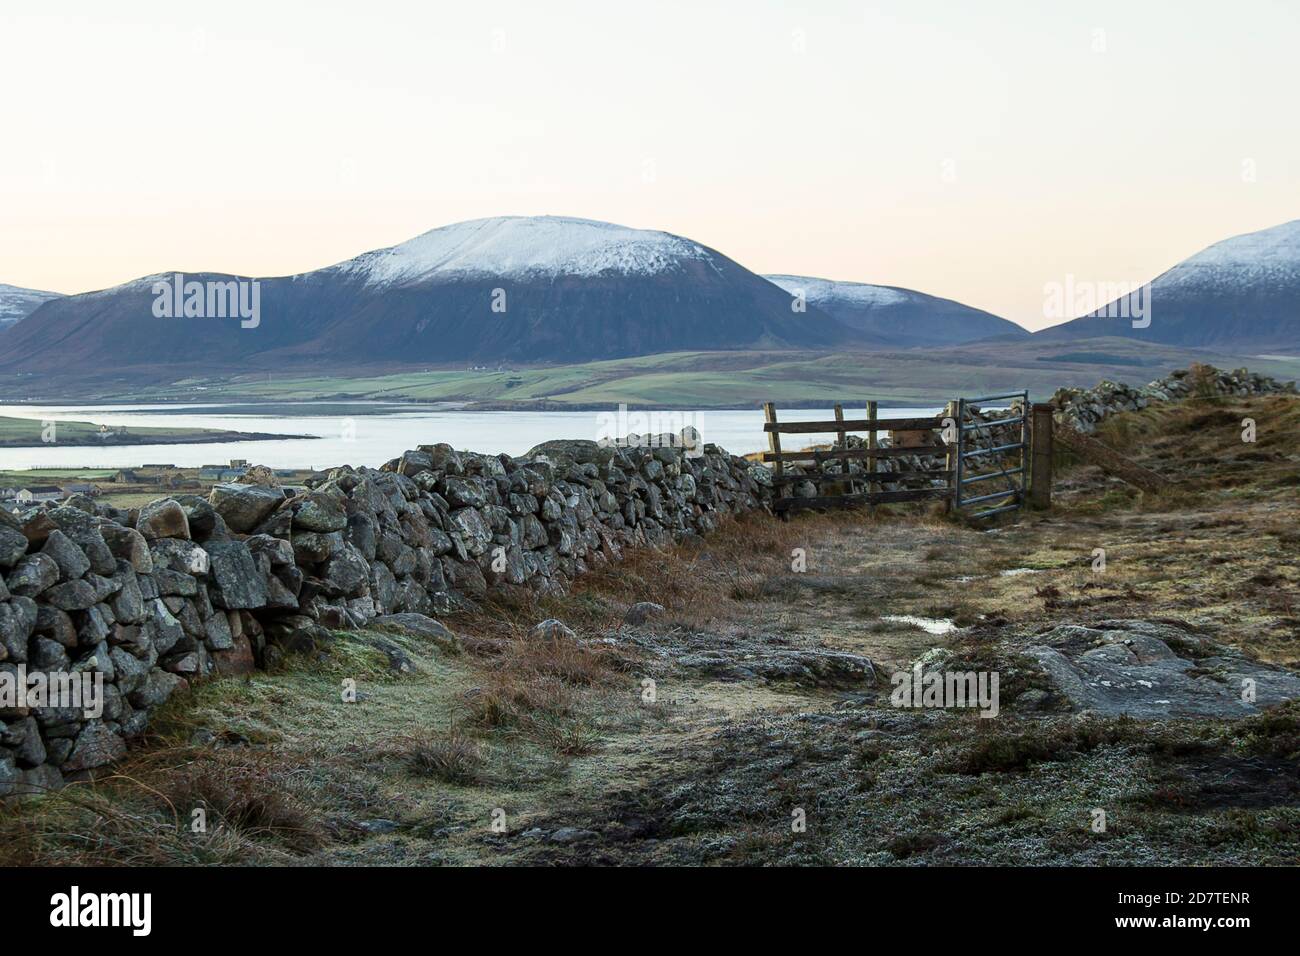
left=0, top=216, right=1300, bottom=380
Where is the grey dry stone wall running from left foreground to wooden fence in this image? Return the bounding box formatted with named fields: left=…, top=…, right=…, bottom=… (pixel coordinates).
left=0, top=436, right=771, bottom=796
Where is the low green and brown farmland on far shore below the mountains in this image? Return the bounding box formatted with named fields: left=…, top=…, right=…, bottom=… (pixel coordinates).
left=0, top=338, right=1300, bottom=408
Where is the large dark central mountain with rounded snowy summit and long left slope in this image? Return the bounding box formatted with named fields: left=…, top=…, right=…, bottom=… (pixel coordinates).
left=0, top=216, right=871, bottom=371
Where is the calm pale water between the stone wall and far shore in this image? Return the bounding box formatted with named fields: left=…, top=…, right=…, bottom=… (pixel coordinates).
left=0, top=402, right=940, bottom=470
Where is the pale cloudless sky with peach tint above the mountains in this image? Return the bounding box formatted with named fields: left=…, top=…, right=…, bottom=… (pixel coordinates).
left=0, top=0, right=1300, bottom=328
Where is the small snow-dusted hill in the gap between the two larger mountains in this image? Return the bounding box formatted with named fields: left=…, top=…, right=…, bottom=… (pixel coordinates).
left=764, top=274, right=1028, bottom=349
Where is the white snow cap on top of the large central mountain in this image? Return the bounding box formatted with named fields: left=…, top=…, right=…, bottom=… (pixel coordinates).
left=335, top=216, right=712, bottom=285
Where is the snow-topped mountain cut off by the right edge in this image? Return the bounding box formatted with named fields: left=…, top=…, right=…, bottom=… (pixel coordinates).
left=1035, top=220, right=1300, bottom=352
